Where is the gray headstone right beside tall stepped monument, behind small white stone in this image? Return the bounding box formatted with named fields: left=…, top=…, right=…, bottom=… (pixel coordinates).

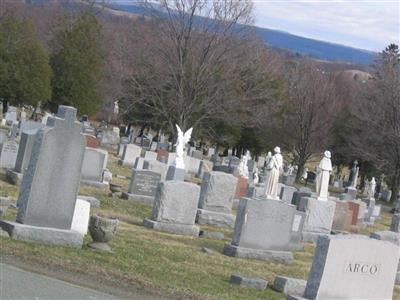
left=81, top=147, right=108, bottom=188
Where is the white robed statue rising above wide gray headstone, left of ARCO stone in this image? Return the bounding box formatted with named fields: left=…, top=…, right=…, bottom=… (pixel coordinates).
left=264, top=147, right=283, bottom=199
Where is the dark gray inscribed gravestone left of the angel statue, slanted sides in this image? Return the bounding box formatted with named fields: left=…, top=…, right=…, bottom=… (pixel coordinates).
left=122, top=169, right=161, bottom=204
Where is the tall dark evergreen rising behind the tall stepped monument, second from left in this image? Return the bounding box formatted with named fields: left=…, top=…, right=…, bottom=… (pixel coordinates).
left=50, top=12, right=104, bottom=114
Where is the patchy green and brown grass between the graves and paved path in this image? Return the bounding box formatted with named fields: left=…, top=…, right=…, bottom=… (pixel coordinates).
left=0, top=153, right=400, bottom=299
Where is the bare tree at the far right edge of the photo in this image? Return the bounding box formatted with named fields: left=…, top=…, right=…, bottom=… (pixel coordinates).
left=348, top=45, right=400, bottom=202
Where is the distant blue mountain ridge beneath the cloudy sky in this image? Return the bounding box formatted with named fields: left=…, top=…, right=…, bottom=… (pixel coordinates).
left=111, top=4, right=378, bottom=65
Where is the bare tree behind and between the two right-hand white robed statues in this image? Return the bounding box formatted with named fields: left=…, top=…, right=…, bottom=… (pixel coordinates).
left=275, top=62, right=335, bottom=180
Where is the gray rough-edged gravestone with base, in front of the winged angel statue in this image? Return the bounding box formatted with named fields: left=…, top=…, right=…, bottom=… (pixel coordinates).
left=143, top=181, right=200, bottom=237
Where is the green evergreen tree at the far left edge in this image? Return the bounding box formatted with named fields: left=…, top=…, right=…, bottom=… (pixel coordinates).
left=0, top=15, right=51, bottom=109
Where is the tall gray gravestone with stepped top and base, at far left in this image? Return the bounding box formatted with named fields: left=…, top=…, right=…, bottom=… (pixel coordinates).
left=0, top=106, right=86, bottom=247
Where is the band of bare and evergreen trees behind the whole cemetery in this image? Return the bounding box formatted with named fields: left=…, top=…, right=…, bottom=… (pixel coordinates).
left=0, top=0, right=400, bottom=200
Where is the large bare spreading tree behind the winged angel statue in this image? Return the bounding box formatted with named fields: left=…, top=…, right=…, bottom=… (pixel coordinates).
left=121, top=0, right=276, bottom=137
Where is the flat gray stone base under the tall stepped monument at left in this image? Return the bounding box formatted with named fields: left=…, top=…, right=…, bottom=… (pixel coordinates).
left=0, top=221, right=83, bottom=248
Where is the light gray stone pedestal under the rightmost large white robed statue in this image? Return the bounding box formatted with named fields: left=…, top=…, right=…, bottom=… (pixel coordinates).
left=298, top=197, right=336, bottom=243
